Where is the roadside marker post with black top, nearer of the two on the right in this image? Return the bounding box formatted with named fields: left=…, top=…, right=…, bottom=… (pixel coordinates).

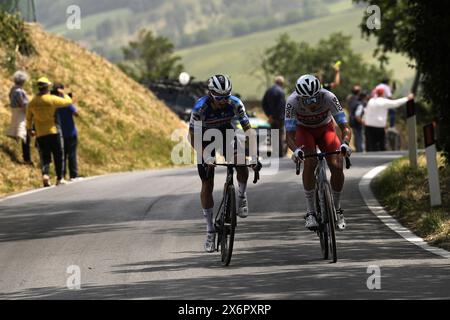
left=423, top=123, right=442, bottom=207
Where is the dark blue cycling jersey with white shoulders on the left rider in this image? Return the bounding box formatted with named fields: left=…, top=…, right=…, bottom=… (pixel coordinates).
left=189, top=96, right=250, bottom=130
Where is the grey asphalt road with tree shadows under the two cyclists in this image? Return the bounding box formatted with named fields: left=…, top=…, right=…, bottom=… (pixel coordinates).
left=0, top=153, right=450, bottom=299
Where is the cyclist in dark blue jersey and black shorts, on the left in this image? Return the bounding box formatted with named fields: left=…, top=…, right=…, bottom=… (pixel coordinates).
left=189, top=75, right=260, bottom=252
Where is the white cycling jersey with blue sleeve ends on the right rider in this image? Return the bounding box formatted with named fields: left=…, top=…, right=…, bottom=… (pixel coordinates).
left=285, top=89, right=347, bottom=132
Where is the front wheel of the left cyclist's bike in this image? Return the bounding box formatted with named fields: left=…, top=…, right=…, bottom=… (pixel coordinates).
left=220, top=185, right=236, bottom=266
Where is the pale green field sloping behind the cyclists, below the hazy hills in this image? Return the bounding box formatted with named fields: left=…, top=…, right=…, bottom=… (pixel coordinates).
left=177, top=2, right=413, bottom=99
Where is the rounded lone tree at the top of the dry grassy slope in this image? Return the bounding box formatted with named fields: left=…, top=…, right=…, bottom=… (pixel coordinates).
left=119, top=30, right=183, bottom=85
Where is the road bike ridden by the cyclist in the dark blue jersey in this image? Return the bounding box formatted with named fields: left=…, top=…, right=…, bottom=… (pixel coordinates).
left=207, top=163, right=261, bottom=266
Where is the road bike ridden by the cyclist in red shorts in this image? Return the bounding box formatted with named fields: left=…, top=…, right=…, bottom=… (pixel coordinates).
left=296, top=150, right=351, bottom=262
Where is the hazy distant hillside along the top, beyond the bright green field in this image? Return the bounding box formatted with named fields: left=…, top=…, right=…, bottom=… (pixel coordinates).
left=36, top=0, right=351, bottom=61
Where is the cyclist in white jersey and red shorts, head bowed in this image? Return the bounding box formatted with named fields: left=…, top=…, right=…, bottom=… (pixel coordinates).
left=285, top=75, right=352, bottom=230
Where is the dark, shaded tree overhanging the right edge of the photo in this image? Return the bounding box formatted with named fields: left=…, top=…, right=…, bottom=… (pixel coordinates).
left=354, top=0, right=450, bottom=164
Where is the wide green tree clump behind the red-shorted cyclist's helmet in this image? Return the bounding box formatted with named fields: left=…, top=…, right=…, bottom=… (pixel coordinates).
left=262, top=33, right=387, bottom=100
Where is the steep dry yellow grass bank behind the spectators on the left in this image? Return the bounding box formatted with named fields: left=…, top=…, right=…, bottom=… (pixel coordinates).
left=0, top=25, right=184, bottom=195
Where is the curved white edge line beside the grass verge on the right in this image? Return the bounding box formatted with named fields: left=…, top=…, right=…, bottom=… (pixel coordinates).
left=359, top=164, right=450, bottom=259
